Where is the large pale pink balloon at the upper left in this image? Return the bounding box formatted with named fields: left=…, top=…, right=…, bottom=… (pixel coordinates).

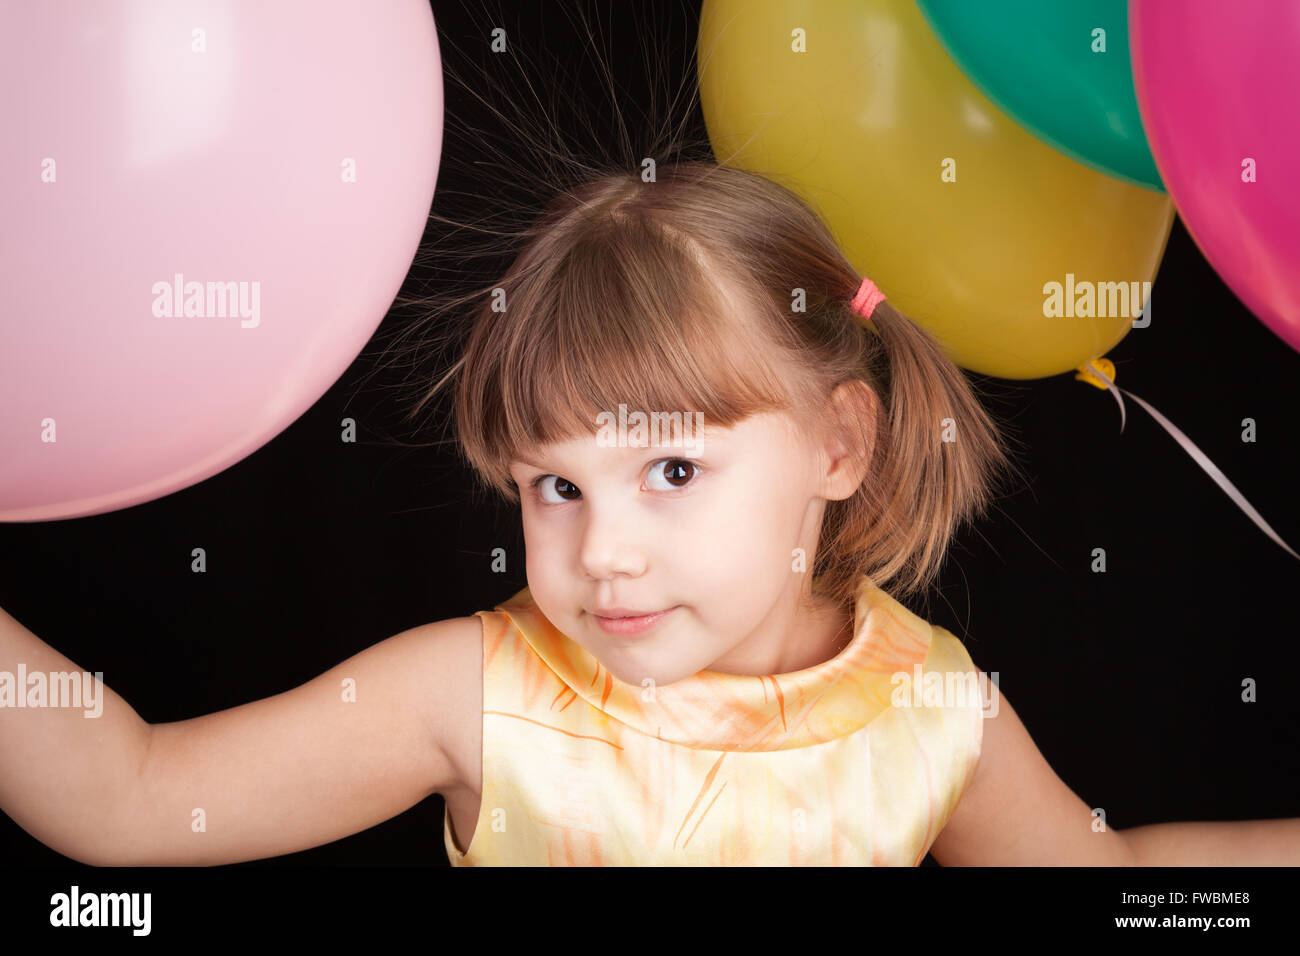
left=0, top=0, right=443, bottom=522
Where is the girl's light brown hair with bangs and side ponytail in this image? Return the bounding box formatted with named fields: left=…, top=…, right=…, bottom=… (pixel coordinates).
left=374, top=5, right=1014, bottom=613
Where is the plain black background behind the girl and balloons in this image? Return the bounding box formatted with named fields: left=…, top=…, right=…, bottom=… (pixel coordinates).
left=0, top=0, right=1300, bottom=868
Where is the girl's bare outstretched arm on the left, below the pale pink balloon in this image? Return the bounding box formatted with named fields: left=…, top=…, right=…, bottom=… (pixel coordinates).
left=0, top=610, right=482, bottom=866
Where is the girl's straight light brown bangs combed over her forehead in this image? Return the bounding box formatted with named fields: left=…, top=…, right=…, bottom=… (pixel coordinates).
left=462, top=227, right=801, bottom=499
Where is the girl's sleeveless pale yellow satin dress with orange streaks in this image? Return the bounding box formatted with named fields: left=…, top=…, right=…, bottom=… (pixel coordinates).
left=443, top=576, right=983, bottom=866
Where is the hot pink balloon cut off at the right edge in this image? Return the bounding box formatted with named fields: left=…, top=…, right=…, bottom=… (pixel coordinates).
left=1128, top=0, right=1300, bottom=350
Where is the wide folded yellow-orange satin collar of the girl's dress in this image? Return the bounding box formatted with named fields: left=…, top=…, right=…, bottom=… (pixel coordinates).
left=497, top=575, right=931, bottom=750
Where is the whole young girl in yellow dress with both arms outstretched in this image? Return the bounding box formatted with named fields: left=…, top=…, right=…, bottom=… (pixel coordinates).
left=0, top=151, right=1297, bottom=865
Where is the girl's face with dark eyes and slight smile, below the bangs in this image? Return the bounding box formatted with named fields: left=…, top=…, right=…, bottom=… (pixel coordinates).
left=511, top=395, right=863, bottom=685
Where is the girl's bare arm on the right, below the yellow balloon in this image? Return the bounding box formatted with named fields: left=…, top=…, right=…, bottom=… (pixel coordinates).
left=931, top=669, right=1300, bottom=866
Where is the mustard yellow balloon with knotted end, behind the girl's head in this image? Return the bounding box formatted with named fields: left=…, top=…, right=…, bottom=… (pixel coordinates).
left=699, top=0, right=1174, bottom=378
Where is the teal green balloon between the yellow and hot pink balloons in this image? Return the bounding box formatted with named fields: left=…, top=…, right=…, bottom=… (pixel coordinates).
left=915, top=0, right=1165, bottom=193
